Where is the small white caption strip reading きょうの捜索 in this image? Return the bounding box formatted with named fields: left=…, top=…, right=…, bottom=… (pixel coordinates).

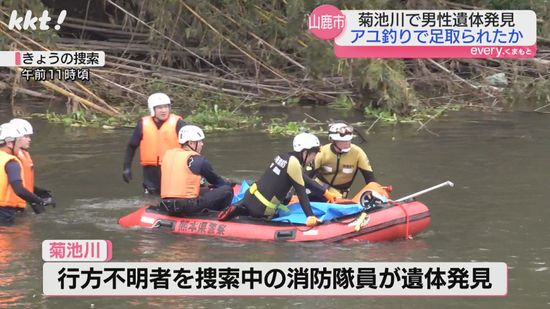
left=0, top=51, right=105, bottom=67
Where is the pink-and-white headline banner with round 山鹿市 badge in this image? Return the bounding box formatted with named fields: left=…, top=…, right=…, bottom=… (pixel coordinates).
left=308, top=5, right=537, bottom=58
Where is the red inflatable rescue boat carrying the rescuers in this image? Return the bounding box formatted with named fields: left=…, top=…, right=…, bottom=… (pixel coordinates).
left=118, top=201, right=430, bottom=242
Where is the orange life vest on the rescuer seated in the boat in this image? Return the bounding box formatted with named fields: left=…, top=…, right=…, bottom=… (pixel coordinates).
left=160, top=148, right=201, bottom=198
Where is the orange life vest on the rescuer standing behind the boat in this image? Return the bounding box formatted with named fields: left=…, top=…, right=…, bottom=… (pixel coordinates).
left=139, top=114, right=181, bottom=166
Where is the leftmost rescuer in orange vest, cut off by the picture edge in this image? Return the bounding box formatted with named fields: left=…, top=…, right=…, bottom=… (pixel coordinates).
left=0, top=123, right=51, bottom=224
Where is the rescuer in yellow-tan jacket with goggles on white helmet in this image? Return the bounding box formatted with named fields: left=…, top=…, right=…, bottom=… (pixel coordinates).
left=309, top=122, right=388, bottom=201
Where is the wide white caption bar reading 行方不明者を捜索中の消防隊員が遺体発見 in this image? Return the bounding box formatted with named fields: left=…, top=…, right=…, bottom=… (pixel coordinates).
left=43, top=262, right=508, bottom=297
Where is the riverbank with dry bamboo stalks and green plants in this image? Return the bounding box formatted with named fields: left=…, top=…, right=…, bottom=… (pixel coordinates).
left=0, top=0, right=550, bottom=133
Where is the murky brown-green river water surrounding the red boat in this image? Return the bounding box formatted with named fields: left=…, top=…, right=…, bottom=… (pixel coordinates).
left=0, top=103, right=550, bottom=308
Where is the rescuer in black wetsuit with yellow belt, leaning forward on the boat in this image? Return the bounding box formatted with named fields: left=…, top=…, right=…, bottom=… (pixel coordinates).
left=218, top=133, right=332, bottom=226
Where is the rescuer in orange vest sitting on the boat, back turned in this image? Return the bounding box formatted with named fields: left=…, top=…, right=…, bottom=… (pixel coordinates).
left=160, top=125, right=233, bottom=216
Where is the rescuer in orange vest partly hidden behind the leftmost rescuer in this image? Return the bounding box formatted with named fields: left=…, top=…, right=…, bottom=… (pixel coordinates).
left=10, top=118, right=55, bottom=204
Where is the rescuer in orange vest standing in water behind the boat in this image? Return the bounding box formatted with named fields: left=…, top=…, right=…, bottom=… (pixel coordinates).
left=122, top=92, right=185, bottom=195
